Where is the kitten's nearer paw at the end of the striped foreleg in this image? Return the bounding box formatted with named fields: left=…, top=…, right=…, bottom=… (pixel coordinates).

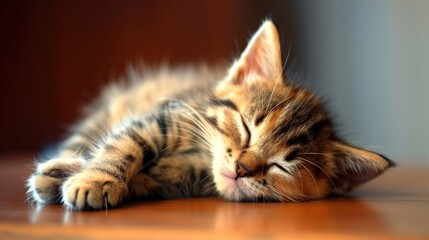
left=62, top=170, right=127, bottom=210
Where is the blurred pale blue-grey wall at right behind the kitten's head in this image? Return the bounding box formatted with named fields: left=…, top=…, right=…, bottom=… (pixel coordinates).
left=295, top=0, right=429, bottom=164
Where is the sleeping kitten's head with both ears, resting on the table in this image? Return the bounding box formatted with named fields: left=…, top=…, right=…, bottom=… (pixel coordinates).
left=207, top=21, right=392, bottom=201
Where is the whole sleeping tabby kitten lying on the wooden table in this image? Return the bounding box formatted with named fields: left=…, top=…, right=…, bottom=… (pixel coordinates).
left=27, top=20, right=393, bottom=210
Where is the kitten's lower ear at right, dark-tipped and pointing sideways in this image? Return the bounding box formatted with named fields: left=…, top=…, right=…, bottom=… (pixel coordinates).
left=334, top=141, right=395, bottom=192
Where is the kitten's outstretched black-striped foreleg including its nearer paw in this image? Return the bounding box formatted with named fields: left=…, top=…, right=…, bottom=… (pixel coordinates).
left=62, top=111, right=192, bottom=210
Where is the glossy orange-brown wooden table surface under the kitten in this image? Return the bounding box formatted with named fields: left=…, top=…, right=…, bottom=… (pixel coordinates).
left=0, top=156, right=429, bottom=239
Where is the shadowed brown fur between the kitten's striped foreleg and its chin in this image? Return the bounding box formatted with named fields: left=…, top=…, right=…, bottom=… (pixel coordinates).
left=128, top=151, right=215, bottom=199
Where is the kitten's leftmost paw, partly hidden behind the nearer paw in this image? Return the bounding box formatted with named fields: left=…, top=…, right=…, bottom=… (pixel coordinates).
left=27, top=158, right=85, bottom=204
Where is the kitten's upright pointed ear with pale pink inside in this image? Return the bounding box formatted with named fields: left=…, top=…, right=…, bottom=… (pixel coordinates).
left=227, top=20, right=282, bottom=84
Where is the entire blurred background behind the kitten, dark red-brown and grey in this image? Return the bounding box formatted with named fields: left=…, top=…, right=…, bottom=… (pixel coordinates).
left=0, top=0, right=429, bottom=165
